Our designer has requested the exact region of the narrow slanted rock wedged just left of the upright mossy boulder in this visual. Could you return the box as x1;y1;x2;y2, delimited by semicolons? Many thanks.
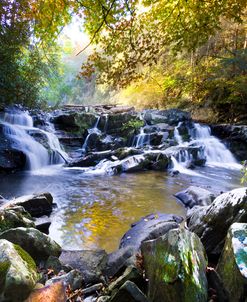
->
108;266;142;292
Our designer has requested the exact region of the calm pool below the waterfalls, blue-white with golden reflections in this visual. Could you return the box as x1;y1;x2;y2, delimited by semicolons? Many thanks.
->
0;165;241;252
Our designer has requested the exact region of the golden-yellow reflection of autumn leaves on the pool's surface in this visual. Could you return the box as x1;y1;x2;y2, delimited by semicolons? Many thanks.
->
58;172;185;252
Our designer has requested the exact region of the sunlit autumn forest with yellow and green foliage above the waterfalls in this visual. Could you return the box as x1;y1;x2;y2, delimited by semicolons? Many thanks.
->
0;0;247;122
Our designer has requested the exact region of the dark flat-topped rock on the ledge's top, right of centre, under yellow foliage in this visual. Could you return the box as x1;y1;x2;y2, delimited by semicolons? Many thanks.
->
144;109;191;125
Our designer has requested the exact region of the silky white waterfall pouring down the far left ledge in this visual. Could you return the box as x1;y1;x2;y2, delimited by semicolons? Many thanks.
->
1;110;67;170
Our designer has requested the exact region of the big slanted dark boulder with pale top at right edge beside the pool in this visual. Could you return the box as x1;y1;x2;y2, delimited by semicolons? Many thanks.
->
187;188;247;256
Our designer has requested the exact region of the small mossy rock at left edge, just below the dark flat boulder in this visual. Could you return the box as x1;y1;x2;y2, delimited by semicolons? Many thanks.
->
0;207;35;233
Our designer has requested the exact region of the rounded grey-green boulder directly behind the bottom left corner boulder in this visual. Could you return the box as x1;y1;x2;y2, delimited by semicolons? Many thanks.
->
0;227;61;263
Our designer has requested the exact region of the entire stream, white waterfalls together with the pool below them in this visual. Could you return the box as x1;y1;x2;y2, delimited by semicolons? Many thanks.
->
0;108;243;251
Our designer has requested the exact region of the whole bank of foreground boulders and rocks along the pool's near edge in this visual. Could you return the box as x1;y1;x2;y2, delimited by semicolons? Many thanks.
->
0;187;247;302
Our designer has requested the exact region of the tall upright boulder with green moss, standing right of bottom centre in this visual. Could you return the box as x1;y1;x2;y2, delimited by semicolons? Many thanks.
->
141;229;208;302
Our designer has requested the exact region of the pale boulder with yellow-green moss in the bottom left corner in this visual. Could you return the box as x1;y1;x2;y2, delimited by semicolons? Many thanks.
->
0;240;38;302
